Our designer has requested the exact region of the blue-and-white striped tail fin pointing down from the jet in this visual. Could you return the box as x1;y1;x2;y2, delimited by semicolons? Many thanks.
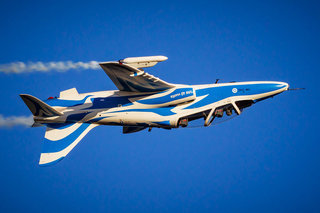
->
39;123;98;166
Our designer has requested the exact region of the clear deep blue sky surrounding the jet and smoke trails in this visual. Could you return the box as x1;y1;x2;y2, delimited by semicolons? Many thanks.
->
0;1;320;212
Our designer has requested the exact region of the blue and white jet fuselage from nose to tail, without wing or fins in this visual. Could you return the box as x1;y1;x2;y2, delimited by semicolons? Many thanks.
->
40;81;288;128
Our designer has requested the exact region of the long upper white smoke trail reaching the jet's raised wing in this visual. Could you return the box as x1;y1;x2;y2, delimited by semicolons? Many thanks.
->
0;61;99;74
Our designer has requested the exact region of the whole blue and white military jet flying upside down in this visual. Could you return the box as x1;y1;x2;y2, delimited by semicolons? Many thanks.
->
20;56;289;165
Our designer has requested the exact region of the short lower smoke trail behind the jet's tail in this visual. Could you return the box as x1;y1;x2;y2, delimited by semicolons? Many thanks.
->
0;114;33;128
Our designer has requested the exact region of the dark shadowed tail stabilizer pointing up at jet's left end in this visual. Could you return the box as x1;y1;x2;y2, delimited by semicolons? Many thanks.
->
20;94;62;117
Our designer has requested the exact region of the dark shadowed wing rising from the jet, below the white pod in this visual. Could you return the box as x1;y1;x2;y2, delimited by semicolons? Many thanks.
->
100;62;174;92
